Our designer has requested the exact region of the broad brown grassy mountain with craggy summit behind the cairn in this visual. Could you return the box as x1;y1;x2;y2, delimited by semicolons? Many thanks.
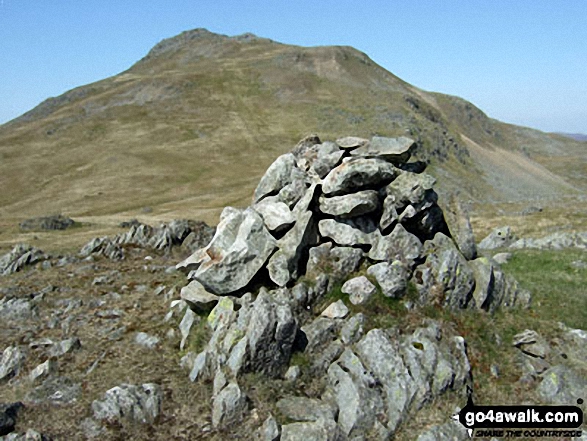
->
0;29;587;227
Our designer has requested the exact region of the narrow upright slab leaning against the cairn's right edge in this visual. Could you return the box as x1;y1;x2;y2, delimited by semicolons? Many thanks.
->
441;194;477;260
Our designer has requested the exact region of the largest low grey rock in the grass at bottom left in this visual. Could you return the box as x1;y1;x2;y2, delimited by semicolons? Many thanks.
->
92;383;163;424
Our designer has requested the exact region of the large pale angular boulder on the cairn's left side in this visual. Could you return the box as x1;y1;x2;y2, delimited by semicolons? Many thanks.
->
194;208;276;295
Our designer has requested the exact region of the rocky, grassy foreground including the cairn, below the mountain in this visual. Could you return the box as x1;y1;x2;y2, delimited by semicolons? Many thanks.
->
0;134;587;441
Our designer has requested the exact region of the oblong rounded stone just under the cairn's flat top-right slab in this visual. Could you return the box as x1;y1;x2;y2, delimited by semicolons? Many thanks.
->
322;158;399;196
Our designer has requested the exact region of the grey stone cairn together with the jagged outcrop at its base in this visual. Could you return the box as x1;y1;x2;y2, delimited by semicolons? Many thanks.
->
177;135;530;439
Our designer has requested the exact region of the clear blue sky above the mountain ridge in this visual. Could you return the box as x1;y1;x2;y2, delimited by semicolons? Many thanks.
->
0;0;587;133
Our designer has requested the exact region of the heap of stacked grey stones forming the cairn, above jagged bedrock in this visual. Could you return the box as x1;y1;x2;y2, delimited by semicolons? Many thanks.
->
177;136;528;311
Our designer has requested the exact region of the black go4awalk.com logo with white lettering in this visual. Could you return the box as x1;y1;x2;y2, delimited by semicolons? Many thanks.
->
453;394;583;439
